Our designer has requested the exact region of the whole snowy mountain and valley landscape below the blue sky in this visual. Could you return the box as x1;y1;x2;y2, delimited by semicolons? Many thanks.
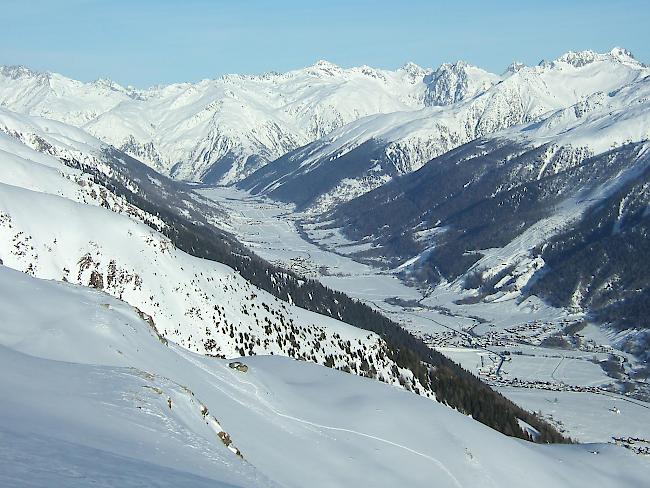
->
0;31;650;488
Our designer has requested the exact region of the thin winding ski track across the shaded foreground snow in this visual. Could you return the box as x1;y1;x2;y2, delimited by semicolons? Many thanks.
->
177;348;462;488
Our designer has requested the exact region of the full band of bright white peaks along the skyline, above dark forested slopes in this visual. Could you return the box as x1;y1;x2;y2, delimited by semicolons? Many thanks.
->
0;48;644;196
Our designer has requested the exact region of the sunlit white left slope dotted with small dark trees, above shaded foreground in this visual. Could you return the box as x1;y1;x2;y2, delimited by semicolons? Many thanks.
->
0;107;422;392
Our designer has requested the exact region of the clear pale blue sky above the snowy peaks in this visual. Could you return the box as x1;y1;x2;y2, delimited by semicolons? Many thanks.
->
0;0;650;87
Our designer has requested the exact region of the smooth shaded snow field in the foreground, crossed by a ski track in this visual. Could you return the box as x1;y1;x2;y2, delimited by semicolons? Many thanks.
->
0;267;650;488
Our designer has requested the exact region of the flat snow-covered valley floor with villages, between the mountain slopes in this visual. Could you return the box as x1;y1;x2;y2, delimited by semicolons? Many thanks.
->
199;187;650;448
